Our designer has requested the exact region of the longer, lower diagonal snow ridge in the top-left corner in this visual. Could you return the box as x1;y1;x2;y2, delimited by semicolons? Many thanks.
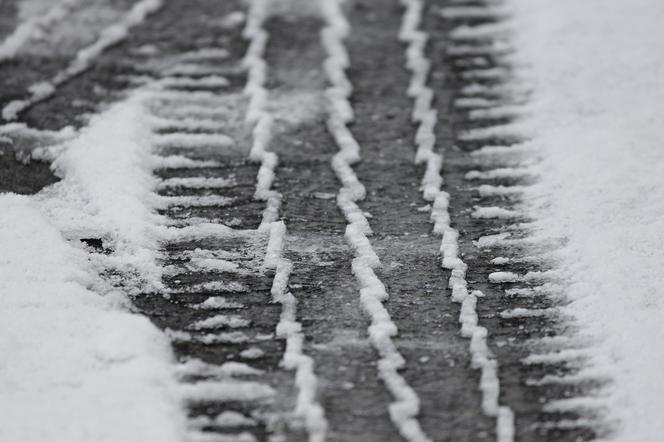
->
2;0;163;120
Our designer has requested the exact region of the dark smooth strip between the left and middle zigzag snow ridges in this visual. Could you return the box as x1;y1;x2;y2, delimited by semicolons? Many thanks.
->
266;9;400;442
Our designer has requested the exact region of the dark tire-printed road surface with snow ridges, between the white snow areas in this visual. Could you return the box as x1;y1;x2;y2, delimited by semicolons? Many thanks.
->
0;0;603;442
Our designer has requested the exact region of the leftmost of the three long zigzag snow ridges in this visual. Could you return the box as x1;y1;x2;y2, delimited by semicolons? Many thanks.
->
243;0;327;442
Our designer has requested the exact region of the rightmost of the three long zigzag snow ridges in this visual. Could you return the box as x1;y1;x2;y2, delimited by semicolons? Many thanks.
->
399;0;514;442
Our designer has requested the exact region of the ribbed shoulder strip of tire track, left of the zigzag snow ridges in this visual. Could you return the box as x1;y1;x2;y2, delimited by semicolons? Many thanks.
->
136;49;293;442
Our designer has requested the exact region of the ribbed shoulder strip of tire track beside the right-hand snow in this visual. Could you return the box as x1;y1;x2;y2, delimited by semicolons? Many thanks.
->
426;1;604;441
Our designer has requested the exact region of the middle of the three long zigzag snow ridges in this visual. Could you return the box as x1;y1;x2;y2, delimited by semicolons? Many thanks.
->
320;0;431;442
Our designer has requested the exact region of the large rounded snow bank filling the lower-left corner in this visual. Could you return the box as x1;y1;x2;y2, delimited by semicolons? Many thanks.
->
0;194;185;442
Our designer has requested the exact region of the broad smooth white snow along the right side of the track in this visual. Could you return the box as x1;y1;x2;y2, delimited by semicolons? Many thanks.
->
510;0;664;442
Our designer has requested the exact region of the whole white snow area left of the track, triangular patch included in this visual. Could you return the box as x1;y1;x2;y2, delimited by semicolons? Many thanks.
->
0;96;185;442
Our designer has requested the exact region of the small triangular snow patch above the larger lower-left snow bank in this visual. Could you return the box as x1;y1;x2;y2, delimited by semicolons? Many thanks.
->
36;94;162;291
